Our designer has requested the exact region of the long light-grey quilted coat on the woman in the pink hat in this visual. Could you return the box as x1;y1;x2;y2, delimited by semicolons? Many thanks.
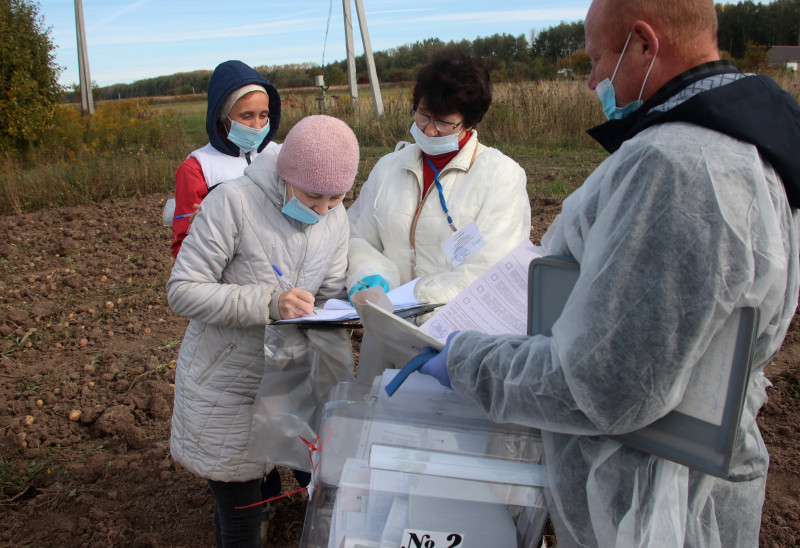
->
167;146;349;482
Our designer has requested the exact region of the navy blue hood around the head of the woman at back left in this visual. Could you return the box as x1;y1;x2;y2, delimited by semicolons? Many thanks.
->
206;61;281;156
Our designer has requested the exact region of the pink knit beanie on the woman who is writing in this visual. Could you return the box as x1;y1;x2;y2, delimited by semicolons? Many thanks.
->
278;114;358;195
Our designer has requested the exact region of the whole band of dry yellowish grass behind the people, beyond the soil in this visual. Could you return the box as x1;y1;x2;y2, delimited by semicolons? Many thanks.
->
0;73;800;214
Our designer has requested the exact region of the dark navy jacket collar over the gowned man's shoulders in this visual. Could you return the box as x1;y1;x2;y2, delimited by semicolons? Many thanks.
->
587;61;800;209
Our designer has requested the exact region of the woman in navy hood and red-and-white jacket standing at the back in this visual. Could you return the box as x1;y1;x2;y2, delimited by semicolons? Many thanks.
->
172;61;281;257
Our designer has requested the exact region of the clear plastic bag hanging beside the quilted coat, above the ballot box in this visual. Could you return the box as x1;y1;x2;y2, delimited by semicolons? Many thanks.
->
249;325;355;472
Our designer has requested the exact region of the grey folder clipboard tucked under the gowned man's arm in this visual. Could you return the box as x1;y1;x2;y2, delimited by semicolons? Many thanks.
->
528;256;758;479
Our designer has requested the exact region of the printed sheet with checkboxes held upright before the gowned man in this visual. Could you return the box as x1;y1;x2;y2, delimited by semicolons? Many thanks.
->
420;240;542;341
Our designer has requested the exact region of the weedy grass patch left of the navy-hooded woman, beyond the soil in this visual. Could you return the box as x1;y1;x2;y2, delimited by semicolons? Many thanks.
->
0;101;186;214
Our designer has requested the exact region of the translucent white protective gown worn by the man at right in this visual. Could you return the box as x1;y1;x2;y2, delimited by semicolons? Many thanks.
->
447;70;800;548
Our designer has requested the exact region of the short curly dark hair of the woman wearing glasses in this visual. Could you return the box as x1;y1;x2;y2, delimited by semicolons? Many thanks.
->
413;48;492;127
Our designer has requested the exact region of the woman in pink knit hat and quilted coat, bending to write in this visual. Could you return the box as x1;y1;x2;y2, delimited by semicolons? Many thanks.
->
167;115;359;547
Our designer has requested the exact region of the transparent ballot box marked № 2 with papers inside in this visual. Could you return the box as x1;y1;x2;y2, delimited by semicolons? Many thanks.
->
300;370;547;548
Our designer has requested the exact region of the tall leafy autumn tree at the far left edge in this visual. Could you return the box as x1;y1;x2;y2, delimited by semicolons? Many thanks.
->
0;0;61;152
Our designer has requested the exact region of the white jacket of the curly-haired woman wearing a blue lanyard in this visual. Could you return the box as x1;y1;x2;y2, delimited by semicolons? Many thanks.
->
347;130;531;303
